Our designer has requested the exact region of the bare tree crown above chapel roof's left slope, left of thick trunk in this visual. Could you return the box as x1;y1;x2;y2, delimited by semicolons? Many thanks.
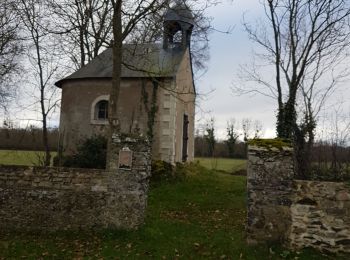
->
48;0;113;68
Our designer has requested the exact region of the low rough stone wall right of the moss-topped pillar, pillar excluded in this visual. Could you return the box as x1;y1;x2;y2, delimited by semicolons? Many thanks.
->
288;180;350;253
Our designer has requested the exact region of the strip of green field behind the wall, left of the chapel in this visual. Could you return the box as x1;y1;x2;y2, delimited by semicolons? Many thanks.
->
0;150;56;166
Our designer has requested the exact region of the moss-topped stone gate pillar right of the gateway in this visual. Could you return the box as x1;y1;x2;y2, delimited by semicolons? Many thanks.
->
247;140;294;244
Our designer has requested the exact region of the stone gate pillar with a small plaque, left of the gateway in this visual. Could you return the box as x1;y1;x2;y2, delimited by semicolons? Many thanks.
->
106;134;151;228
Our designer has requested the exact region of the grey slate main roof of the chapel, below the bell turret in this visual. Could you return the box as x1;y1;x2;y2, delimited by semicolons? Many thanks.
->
55;43;185;87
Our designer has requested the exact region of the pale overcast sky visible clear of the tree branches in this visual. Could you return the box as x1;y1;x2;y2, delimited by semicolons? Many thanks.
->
2;0;350;139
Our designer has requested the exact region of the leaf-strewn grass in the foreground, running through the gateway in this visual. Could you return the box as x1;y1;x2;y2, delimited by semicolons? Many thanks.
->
0;166;338;260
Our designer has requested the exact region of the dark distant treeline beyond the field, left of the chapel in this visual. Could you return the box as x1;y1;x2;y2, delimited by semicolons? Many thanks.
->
0;127;58;151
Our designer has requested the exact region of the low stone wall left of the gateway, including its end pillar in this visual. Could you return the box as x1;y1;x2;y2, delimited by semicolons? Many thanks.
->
0;135;151;232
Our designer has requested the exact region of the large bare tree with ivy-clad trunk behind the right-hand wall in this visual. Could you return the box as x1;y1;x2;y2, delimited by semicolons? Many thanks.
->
239;0;350;176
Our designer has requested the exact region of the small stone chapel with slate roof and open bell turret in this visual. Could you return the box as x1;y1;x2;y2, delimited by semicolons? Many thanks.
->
56;3;196;163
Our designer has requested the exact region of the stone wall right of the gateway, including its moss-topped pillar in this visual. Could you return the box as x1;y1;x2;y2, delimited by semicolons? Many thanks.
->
247;143;350;253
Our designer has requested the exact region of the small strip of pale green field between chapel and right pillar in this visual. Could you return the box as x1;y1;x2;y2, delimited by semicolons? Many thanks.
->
195;158;247;173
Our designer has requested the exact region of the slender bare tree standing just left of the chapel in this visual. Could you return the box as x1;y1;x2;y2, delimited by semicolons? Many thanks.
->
16;0;59;166
